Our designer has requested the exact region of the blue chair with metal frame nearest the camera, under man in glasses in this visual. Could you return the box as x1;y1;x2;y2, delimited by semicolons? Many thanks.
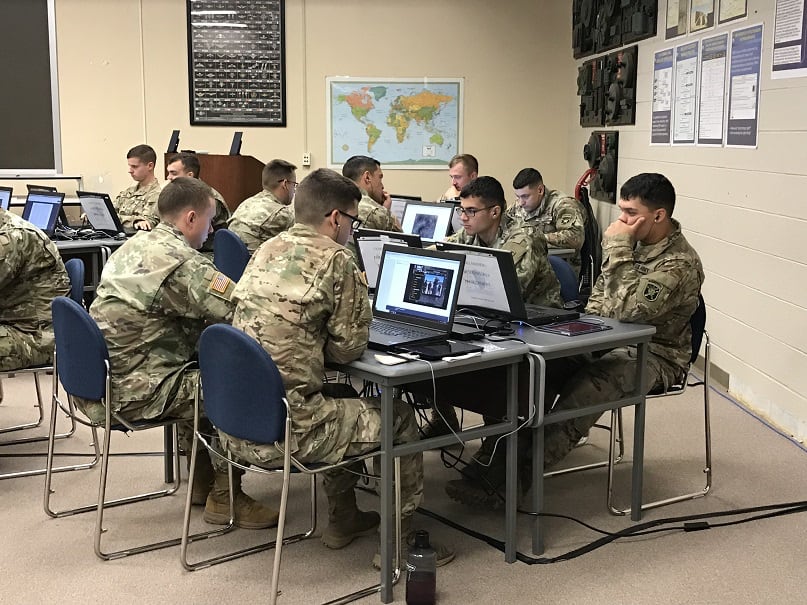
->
180;324;401;604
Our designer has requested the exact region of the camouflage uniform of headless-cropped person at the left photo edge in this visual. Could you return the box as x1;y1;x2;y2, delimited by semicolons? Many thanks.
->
0;208;70;370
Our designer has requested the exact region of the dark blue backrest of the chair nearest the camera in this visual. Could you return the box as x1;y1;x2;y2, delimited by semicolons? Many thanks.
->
199;324;286;443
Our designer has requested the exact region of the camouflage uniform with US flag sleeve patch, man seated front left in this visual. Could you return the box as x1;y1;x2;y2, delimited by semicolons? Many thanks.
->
77;223;235;448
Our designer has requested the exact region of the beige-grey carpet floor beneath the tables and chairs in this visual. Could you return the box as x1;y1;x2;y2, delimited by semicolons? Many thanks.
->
0;368;807;605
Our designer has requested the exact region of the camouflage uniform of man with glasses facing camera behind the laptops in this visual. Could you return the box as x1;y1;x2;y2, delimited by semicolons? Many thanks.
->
446;214;563;308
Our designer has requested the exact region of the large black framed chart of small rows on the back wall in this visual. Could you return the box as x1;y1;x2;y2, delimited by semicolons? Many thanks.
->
186;0;286;126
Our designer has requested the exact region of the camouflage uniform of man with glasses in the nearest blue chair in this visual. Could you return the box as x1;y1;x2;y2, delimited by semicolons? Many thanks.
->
220;223;423;515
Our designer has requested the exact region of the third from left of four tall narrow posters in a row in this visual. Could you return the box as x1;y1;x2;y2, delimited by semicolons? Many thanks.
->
698;34;729;145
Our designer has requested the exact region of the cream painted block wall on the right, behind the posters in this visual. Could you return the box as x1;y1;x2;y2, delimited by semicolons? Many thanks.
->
567;0;807;441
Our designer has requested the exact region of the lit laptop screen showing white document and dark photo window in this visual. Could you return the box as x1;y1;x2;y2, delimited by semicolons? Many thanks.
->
373;246;464;326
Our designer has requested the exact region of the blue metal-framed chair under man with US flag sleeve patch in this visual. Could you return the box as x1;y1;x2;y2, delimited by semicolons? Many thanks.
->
44;297;180;560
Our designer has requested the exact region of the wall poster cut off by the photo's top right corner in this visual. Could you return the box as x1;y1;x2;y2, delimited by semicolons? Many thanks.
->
771;0;807;80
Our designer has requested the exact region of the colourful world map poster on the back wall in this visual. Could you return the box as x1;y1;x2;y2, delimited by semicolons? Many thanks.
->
327;77;463;170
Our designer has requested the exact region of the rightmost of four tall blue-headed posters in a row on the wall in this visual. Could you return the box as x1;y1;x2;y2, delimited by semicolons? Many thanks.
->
726;23;762;147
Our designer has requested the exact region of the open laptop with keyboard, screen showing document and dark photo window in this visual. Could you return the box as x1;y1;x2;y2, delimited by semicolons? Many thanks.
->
368;244;465;351
